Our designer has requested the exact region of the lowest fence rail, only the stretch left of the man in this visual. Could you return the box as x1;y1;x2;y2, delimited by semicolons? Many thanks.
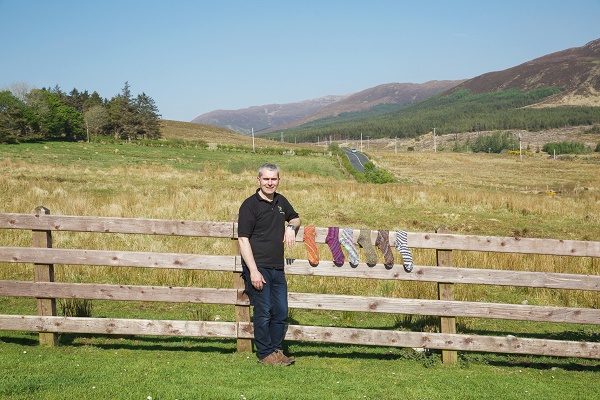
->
0;315;237;338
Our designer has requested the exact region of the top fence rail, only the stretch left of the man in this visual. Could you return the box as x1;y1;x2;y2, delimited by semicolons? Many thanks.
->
0;213;234;238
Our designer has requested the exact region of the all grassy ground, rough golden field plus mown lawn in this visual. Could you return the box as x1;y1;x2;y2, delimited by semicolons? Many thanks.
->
0;130;600;400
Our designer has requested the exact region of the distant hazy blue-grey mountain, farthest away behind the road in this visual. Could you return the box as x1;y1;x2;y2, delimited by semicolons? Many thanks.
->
192;96;348;135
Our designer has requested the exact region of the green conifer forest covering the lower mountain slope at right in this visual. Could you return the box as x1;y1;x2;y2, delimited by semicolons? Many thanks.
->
264;87;600;142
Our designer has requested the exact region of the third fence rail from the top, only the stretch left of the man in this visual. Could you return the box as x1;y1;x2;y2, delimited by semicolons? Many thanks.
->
0;280;239;305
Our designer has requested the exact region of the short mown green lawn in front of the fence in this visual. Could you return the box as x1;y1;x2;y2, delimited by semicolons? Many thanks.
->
0;332;600;400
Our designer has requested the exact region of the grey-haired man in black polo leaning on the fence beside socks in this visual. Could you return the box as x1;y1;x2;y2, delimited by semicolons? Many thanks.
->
238;164;300;366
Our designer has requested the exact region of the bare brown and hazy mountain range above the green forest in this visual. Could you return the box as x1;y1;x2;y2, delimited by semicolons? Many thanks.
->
192;39;600;134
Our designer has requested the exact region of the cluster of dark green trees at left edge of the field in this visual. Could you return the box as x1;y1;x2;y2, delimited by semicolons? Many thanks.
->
0;82;161;143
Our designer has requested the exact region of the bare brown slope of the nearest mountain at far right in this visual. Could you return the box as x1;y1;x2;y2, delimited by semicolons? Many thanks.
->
451;39;600;107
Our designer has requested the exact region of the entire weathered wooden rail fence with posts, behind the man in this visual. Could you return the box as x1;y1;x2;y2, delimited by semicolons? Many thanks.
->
0;207;600;363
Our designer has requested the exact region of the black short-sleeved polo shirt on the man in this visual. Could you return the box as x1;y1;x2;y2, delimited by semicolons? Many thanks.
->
238;189;298;269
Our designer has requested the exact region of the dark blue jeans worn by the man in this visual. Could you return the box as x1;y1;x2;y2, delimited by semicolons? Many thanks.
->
244;267;288;359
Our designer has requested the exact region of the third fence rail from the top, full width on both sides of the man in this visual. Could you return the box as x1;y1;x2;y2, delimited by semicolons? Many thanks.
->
0;281;600;325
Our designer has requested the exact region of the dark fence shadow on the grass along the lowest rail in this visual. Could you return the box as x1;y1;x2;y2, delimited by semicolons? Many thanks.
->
0;330;600;372
